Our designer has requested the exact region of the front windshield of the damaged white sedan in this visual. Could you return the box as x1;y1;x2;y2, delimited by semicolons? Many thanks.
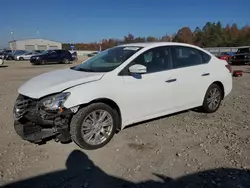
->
71;46;142;72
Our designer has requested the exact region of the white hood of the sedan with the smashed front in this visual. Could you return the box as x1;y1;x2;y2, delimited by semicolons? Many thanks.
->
18;68;105;99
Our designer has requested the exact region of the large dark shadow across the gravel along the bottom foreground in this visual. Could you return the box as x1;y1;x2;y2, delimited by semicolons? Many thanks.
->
3;150;250;188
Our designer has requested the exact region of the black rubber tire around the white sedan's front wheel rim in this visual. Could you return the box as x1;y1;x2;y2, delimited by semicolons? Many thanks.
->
70;103;120;150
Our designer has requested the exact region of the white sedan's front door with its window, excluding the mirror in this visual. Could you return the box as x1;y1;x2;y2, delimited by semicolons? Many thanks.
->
122;47;176;124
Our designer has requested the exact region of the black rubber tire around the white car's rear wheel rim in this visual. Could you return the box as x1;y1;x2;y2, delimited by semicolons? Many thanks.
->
201;84;223;113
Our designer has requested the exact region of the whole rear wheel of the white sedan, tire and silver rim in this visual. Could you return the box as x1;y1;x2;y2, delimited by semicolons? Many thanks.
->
202;84;223;113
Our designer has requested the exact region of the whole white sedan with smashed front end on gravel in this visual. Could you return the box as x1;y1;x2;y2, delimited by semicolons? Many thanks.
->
13;42;232;149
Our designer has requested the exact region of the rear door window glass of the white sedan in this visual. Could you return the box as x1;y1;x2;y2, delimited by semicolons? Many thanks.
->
172;46;211;68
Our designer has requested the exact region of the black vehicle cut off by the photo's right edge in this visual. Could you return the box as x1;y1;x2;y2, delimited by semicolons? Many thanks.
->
231;46;250;65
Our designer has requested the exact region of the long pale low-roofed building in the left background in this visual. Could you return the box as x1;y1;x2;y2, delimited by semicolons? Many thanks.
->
9;38;62;51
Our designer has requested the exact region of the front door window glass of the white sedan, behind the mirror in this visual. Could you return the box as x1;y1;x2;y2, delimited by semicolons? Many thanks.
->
133;47;171;73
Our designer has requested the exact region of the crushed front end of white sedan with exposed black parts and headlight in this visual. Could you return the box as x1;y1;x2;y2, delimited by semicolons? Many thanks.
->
13;93;73;144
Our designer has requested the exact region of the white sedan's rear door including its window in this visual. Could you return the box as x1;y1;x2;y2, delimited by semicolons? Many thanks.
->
171;46;212;110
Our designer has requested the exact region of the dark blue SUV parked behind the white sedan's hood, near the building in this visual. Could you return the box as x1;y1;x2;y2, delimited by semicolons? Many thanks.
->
30;50;74;65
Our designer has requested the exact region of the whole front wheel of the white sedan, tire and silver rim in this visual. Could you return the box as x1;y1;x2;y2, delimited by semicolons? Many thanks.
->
70;103;119;150
